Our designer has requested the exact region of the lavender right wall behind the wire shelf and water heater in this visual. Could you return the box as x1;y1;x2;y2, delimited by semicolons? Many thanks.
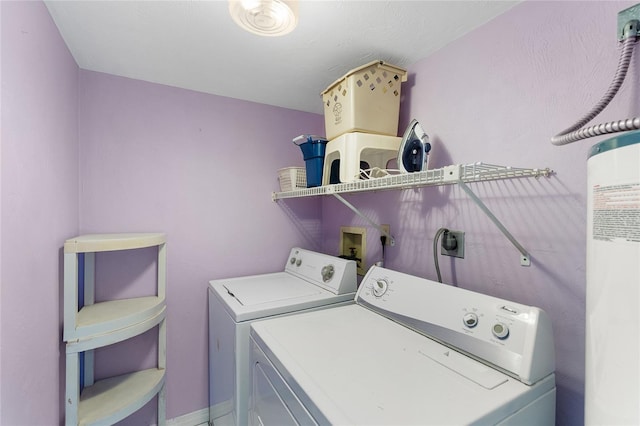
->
323;1;640;425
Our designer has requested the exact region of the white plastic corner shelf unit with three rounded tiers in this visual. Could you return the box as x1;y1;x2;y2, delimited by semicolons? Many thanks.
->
63;233;167;425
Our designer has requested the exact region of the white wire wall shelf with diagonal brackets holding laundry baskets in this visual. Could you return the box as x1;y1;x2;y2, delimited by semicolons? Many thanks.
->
271;162;553;266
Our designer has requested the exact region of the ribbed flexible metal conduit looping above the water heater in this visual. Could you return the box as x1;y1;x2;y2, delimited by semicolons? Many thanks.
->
551;37;640;146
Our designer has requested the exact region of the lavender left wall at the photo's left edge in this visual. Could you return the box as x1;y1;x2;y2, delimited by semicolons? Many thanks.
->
0;1;78;425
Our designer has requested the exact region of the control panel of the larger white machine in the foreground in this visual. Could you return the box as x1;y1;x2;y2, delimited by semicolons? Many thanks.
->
356;266;555;384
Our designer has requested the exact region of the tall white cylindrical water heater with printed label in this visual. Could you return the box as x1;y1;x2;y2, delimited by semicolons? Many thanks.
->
585;131;640;425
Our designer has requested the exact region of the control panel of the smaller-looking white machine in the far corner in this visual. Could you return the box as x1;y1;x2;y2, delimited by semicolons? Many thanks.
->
284;247;358;294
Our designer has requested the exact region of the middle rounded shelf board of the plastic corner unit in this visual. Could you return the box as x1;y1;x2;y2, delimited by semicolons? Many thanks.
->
65;296;165;341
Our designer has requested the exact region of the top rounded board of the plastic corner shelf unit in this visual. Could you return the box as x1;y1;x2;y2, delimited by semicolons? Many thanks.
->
64;233;166;253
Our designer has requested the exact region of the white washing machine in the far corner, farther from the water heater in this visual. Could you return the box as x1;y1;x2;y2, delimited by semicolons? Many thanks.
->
208;248;357;426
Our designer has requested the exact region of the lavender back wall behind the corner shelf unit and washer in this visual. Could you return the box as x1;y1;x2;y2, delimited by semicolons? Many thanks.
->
79;71;323;424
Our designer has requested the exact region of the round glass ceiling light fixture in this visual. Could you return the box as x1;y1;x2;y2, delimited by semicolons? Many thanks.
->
229;0;298;36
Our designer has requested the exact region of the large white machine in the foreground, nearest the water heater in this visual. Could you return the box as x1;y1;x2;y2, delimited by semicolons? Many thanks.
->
249;266;556;426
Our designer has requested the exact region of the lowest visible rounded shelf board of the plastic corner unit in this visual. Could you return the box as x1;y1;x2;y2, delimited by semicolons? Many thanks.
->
78;368;165;425
